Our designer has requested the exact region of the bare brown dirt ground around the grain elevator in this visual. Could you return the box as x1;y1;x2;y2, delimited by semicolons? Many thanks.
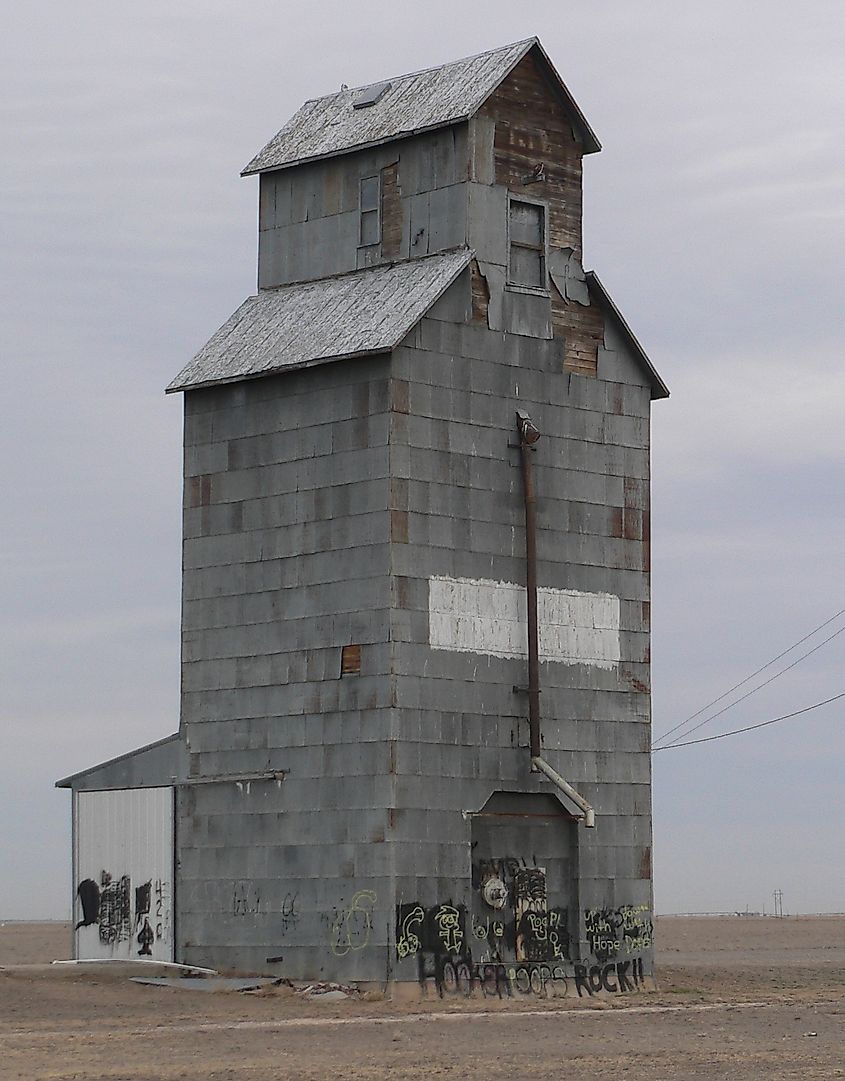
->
0;916;845;1081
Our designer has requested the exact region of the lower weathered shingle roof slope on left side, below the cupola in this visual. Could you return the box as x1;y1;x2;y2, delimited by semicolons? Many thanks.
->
167;248;472;393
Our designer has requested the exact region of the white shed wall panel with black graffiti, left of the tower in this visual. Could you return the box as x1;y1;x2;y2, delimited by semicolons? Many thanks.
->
73;788;173;961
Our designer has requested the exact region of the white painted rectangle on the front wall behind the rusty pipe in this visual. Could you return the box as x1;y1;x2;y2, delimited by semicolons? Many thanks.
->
428;577;620;668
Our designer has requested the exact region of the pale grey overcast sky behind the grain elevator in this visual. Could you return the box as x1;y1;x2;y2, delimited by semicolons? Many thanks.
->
0;0;845;919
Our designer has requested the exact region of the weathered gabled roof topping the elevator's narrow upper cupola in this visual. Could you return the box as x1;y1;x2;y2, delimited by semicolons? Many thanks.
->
241;38;601;176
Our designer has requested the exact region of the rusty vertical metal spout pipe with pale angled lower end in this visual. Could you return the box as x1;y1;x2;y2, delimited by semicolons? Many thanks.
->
517;410;595;829
